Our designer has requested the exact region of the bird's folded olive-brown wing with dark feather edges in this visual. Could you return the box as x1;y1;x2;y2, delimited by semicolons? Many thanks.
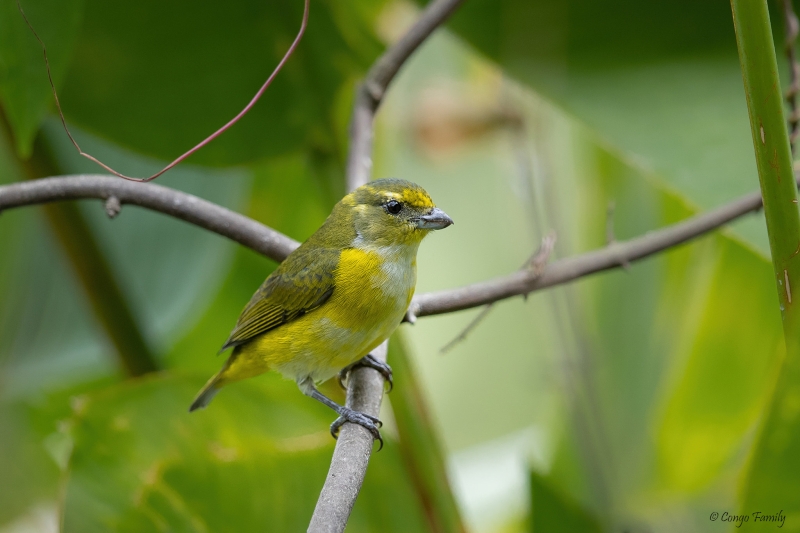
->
220;248;341;351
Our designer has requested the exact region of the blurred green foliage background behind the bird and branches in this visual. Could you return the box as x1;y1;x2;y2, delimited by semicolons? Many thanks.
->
0;0;800;533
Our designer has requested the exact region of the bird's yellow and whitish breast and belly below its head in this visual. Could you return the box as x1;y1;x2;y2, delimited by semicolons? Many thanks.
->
230;243;416;381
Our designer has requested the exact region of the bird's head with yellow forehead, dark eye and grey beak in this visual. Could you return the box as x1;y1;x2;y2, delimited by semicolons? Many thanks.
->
334;179;453;246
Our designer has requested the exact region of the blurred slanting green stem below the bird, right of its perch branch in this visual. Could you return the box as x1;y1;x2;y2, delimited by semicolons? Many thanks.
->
388;333;466;533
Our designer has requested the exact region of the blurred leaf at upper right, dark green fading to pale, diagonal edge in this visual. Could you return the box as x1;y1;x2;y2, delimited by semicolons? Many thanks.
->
438;0;767;251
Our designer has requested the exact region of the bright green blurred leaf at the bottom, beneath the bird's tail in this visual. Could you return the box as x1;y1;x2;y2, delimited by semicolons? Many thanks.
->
64;375;432;533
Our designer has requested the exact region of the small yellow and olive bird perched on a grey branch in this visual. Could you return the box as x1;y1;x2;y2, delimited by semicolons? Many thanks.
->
189;179;453;440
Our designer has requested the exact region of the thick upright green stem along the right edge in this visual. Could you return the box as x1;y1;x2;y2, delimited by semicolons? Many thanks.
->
731;0;800;516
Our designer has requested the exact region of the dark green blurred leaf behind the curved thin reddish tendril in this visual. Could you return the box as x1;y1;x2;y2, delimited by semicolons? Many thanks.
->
55;0;382;165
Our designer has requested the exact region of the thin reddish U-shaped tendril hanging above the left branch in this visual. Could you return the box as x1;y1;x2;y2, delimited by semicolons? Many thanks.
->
17;0;309;182
